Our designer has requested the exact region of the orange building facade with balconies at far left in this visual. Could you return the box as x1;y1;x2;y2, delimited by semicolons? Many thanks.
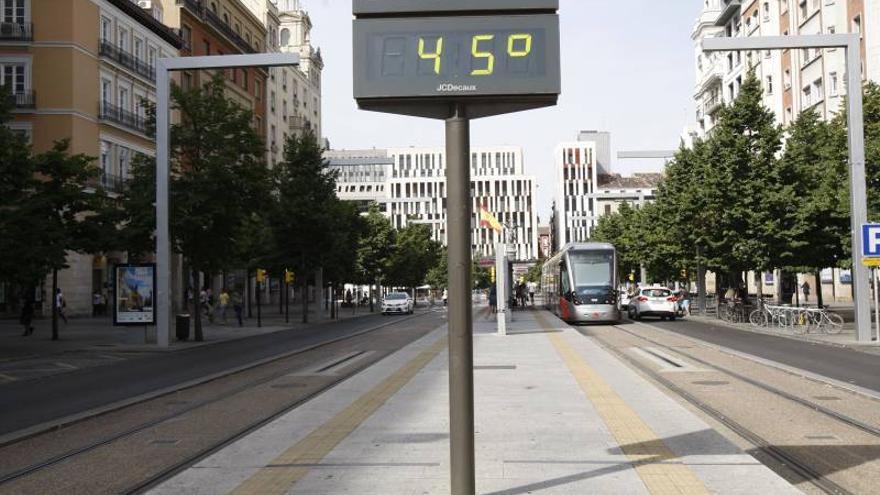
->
0;0;182;314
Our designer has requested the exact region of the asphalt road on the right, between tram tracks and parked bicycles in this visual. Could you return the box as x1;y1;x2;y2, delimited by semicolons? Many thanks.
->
644;319;880;392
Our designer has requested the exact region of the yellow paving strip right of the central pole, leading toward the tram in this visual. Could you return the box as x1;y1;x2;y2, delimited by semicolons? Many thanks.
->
537;313;709;495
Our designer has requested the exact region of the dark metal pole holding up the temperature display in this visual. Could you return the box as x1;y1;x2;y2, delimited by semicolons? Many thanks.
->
446;105;476;495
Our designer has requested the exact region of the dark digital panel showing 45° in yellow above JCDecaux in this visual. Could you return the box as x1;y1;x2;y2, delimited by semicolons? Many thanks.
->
354;14;560;98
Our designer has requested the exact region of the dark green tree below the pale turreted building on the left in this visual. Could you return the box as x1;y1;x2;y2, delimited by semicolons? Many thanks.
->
269;133;339;323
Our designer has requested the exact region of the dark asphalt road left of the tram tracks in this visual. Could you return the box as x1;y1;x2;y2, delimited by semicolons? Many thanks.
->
0;315;438;435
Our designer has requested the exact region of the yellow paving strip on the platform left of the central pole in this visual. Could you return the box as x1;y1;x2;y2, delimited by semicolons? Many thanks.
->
231;337;447;495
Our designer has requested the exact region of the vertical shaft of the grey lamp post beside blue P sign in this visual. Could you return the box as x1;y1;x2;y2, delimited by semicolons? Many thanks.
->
846;36;871;342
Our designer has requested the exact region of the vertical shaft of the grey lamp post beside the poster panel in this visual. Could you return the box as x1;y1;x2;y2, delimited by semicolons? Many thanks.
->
156;59;171;347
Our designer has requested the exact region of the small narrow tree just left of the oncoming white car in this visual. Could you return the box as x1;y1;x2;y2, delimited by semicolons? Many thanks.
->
357;204;396;312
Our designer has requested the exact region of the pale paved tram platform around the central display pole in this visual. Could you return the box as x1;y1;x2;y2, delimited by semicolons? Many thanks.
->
151;308;800;495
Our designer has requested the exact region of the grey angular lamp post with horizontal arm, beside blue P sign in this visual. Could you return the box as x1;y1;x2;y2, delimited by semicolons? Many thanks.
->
702;33;871;342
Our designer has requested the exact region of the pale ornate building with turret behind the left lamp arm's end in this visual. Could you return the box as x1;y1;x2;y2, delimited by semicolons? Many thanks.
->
241;0;324;167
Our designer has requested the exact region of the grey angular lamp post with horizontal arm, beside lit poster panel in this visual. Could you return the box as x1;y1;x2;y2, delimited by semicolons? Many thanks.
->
155;53;299;347
